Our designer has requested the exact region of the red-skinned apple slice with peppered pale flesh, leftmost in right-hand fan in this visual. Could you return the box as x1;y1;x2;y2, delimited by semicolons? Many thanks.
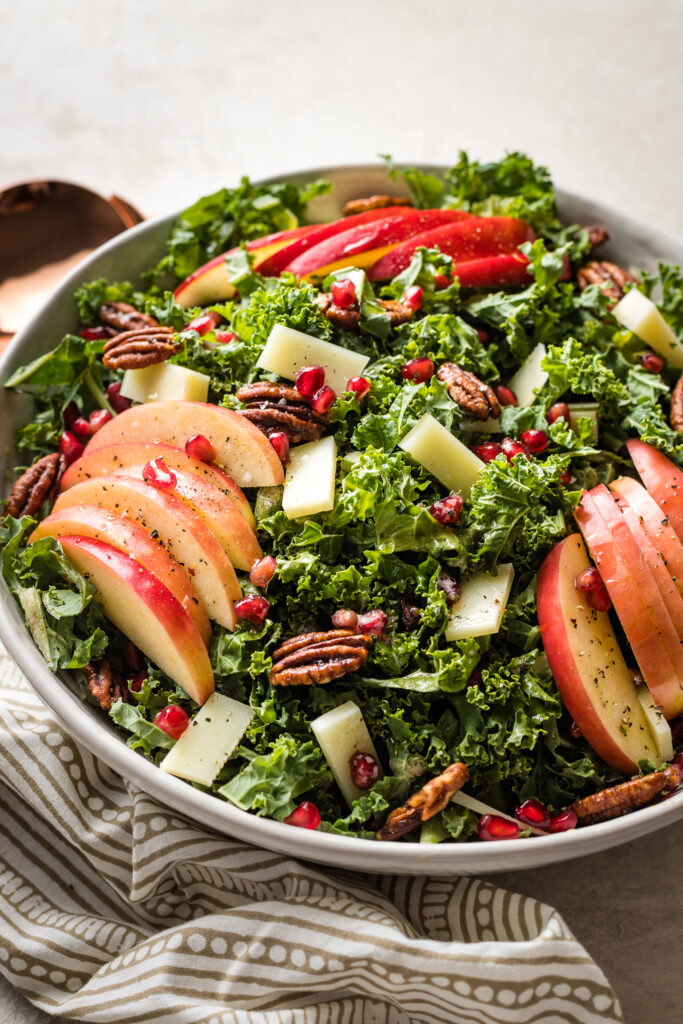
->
537;534;657;775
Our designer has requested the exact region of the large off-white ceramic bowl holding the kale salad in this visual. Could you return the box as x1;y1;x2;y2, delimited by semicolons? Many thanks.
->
0;165;683;876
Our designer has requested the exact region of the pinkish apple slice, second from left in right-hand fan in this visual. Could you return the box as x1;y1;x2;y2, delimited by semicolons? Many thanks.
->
574;484;683;720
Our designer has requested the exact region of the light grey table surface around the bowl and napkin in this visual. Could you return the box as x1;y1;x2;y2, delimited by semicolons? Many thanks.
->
0;0;683;1024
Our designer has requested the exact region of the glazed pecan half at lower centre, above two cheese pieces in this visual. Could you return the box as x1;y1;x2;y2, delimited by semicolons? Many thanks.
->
268;630;373;686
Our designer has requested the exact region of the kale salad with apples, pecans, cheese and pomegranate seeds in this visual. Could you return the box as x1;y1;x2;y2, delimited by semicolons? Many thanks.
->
0;153;683;843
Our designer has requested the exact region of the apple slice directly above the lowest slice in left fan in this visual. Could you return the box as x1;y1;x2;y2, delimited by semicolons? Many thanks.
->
29;505;211;645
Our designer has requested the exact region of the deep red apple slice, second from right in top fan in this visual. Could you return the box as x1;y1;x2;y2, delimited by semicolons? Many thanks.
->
368;217;536;281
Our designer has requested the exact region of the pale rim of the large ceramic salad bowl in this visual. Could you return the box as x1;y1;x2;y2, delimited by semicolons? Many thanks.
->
0;163;683;874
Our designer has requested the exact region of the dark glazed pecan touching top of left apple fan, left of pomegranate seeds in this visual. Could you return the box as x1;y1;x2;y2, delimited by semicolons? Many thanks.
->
238;381;330;444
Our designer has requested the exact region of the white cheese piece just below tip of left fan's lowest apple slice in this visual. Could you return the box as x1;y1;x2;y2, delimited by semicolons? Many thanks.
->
160;693;254;785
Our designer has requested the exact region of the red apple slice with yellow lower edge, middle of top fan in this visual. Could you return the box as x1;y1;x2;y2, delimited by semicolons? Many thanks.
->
285;209;470;280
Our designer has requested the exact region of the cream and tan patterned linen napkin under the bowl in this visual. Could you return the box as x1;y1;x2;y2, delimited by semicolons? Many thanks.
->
0;648;623;1024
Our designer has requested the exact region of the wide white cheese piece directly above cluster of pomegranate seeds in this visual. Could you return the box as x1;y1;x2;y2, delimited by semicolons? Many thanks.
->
256;324;370;393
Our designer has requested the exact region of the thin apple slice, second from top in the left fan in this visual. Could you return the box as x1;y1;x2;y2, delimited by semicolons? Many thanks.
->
59;441;256;529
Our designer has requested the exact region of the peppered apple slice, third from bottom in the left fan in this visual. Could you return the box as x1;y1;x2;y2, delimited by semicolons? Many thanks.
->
53;476;237;630
